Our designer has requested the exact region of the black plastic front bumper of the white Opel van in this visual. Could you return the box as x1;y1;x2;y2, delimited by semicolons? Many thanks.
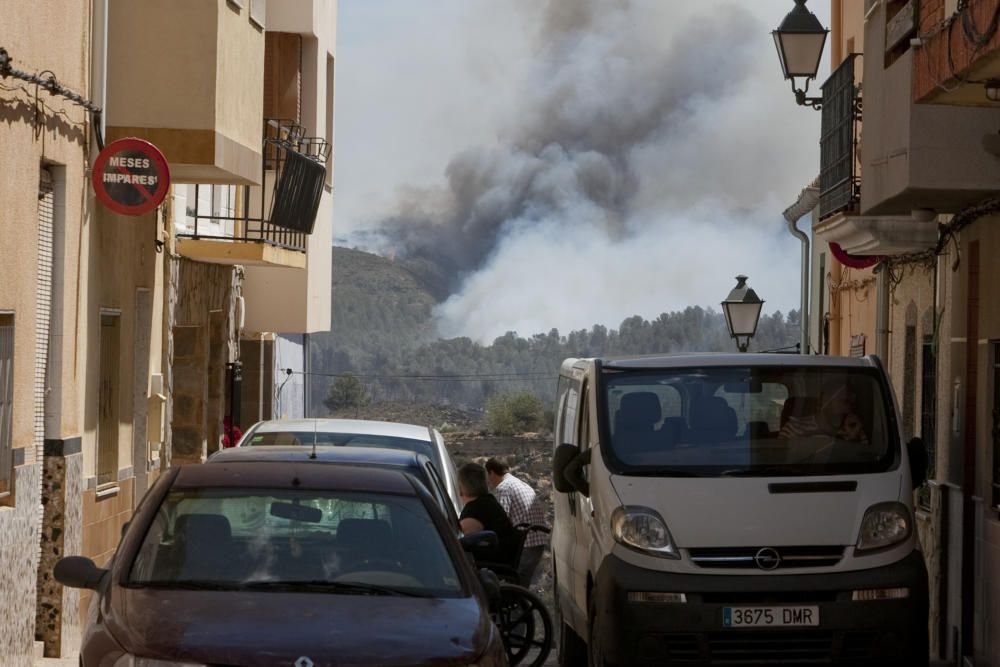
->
593;551;928;667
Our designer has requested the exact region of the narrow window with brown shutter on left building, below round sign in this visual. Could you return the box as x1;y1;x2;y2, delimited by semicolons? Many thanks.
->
97;312;121;488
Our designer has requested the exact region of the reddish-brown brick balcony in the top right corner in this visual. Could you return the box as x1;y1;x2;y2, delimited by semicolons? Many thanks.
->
913;0;1000;108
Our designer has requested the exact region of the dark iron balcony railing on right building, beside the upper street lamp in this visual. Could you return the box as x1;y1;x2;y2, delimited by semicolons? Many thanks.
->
819;54;861;220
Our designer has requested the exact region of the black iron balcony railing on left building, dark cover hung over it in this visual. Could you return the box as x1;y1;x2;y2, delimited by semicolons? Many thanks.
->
177;119;330;252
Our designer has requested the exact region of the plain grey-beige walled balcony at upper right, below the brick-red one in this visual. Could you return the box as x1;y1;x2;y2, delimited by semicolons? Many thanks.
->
860;2;1000;218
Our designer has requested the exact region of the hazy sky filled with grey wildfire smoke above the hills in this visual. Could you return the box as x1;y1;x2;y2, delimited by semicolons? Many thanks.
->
334;0;830;342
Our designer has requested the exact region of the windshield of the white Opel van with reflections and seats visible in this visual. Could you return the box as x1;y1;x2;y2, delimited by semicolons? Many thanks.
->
602;366;898;477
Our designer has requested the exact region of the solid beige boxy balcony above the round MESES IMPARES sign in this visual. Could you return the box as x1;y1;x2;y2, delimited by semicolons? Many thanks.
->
107;0;264;185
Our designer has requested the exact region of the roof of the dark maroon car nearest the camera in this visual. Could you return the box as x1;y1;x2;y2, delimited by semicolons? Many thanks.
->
173;461;416;496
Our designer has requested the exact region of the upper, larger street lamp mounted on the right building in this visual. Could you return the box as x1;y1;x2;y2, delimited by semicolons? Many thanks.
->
771;0;830;109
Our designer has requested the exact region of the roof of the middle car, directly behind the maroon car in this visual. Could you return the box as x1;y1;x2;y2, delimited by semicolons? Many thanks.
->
206;445;427;467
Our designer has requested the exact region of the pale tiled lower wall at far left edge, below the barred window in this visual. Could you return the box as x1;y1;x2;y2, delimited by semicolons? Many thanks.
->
0;464;41;667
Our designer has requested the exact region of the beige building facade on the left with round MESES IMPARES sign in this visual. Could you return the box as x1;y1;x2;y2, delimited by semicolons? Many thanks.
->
0;0;336;667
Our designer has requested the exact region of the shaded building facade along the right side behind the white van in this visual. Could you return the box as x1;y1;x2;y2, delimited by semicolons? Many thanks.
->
796;0;1000;665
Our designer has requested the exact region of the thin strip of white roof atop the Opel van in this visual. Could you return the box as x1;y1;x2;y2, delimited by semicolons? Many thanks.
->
563;352;876;371
